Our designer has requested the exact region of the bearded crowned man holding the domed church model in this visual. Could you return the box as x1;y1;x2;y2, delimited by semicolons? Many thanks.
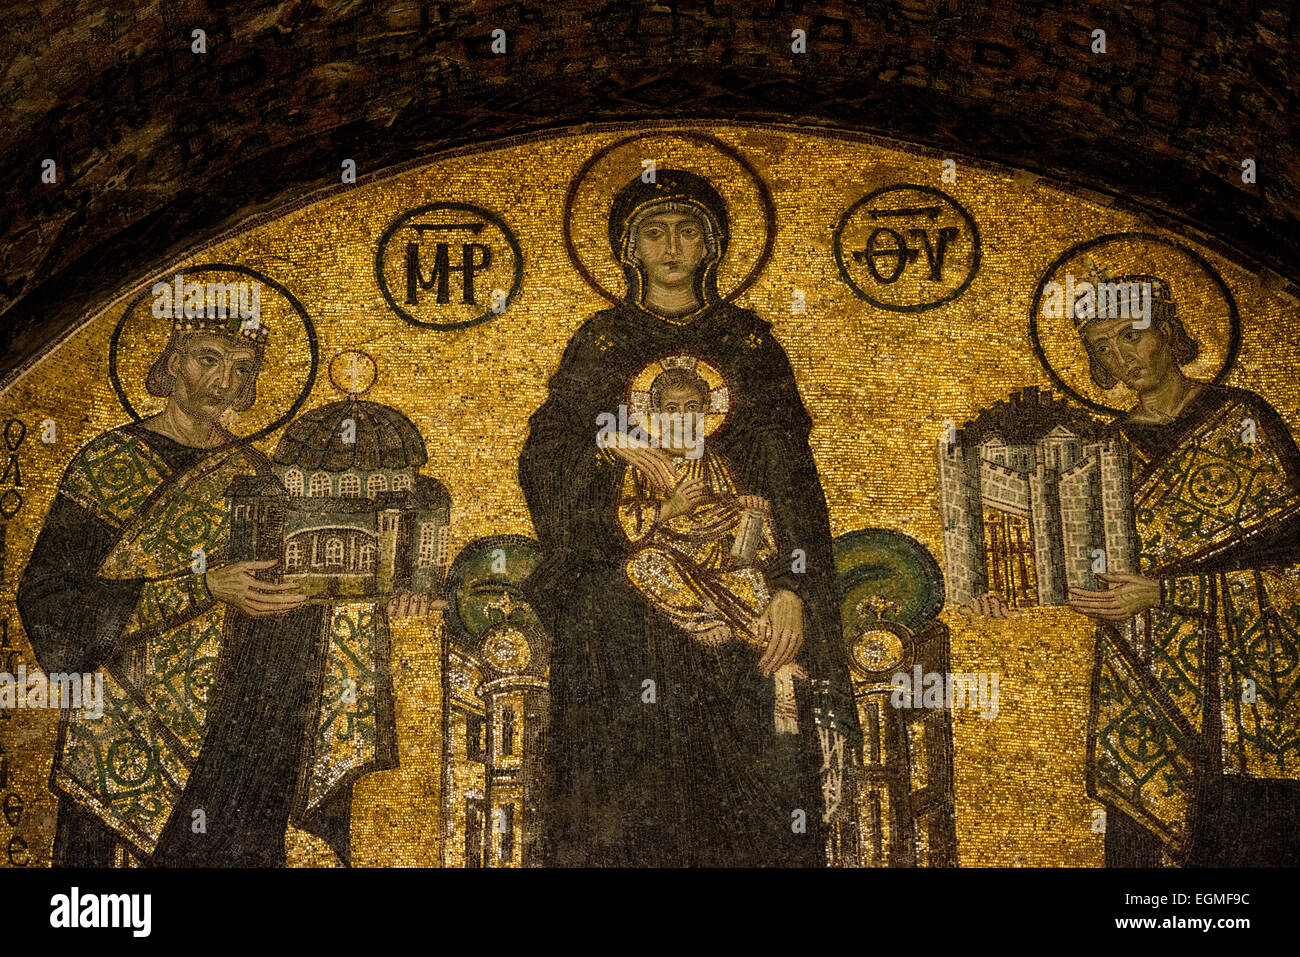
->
17;309;390;867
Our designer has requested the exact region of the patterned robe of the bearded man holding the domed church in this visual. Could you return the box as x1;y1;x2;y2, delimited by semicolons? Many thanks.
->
18;424;395;866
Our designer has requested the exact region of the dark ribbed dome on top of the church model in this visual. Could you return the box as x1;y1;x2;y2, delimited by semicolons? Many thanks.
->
272;398;429;472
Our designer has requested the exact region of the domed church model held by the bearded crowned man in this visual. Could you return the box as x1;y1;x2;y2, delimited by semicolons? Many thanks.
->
226;395;451;599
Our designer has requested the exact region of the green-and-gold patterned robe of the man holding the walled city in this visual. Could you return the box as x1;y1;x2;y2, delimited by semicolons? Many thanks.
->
1088;386;1300;863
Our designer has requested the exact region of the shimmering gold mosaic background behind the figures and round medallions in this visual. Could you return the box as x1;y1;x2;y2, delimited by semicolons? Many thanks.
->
0;125;1300;866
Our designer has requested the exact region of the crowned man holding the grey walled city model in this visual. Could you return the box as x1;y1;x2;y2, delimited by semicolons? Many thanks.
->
975;273;1300;867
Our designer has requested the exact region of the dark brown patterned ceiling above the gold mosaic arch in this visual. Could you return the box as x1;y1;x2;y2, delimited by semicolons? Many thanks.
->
0;0;1300;374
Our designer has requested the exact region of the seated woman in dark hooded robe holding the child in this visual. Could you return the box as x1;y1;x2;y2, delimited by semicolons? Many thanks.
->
519;169;857;866
